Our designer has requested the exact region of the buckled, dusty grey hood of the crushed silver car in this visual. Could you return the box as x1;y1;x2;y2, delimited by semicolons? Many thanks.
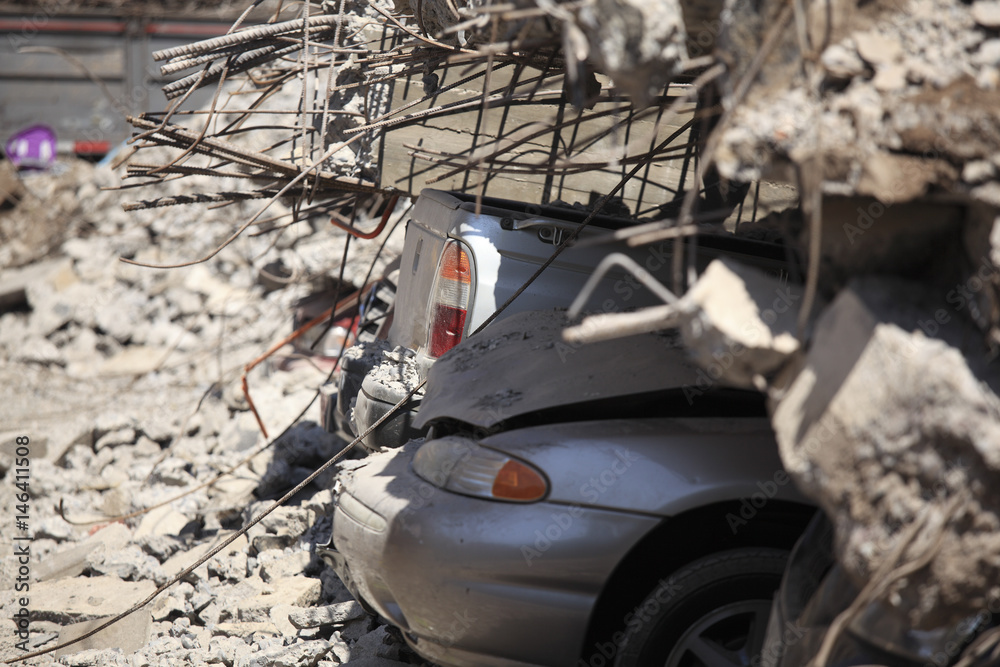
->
414;310;711;428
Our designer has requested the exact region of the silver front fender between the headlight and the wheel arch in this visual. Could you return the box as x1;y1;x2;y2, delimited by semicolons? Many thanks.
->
481;418;809;517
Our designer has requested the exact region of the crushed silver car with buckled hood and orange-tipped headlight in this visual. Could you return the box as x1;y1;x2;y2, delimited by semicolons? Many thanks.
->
324;311;812;667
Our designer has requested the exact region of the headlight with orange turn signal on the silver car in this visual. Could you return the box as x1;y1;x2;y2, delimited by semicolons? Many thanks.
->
413;437;549;503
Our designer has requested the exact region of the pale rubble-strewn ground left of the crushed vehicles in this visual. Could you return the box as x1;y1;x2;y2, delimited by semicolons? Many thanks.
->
0;154;415;667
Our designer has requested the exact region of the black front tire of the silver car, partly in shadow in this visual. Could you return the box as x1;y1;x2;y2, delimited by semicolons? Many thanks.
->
615;548;788;667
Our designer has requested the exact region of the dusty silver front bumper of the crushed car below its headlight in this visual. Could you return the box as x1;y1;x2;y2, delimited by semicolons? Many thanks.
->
334;445;659;667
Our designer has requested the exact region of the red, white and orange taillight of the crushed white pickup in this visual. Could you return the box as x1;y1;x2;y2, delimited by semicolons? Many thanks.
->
429;241;472;358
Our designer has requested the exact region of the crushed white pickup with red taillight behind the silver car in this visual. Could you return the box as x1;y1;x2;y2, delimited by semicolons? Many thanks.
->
323;190;788;451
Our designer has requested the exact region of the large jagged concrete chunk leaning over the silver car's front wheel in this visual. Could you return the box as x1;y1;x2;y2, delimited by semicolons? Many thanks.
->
772;278;1000;628
